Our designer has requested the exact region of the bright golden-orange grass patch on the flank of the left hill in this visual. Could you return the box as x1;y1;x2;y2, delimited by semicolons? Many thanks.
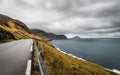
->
0;20;40;39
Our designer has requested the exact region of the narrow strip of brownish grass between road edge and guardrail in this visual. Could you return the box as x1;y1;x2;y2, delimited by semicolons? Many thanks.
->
31;41;40;75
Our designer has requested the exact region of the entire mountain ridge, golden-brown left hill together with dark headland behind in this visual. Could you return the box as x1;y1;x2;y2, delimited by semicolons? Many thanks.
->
0;14;67;41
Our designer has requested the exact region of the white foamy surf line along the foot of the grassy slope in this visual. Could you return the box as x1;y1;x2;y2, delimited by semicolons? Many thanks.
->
49;43;120;74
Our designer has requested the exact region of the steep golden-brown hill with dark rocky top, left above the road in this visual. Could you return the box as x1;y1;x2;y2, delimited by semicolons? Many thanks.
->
0;14;41;41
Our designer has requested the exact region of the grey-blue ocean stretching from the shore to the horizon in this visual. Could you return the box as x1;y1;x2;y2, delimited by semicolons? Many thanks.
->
50;39;120;70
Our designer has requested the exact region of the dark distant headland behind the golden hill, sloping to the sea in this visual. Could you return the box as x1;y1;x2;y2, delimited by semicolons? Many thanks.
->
31;29;67;39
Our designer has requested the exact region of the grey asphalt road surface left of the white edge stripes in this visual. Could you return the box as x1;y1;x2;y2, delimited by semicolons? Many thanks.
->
0;39;33;75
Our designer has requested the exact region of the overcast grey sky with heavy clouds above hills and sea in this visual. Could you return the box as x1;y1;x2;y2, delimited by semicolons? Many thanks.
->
0;0;120;38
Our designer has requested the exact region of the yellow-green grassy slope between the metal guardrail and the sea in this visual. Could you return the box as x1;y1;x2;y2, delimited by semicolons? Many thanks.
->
39;41;118;75
